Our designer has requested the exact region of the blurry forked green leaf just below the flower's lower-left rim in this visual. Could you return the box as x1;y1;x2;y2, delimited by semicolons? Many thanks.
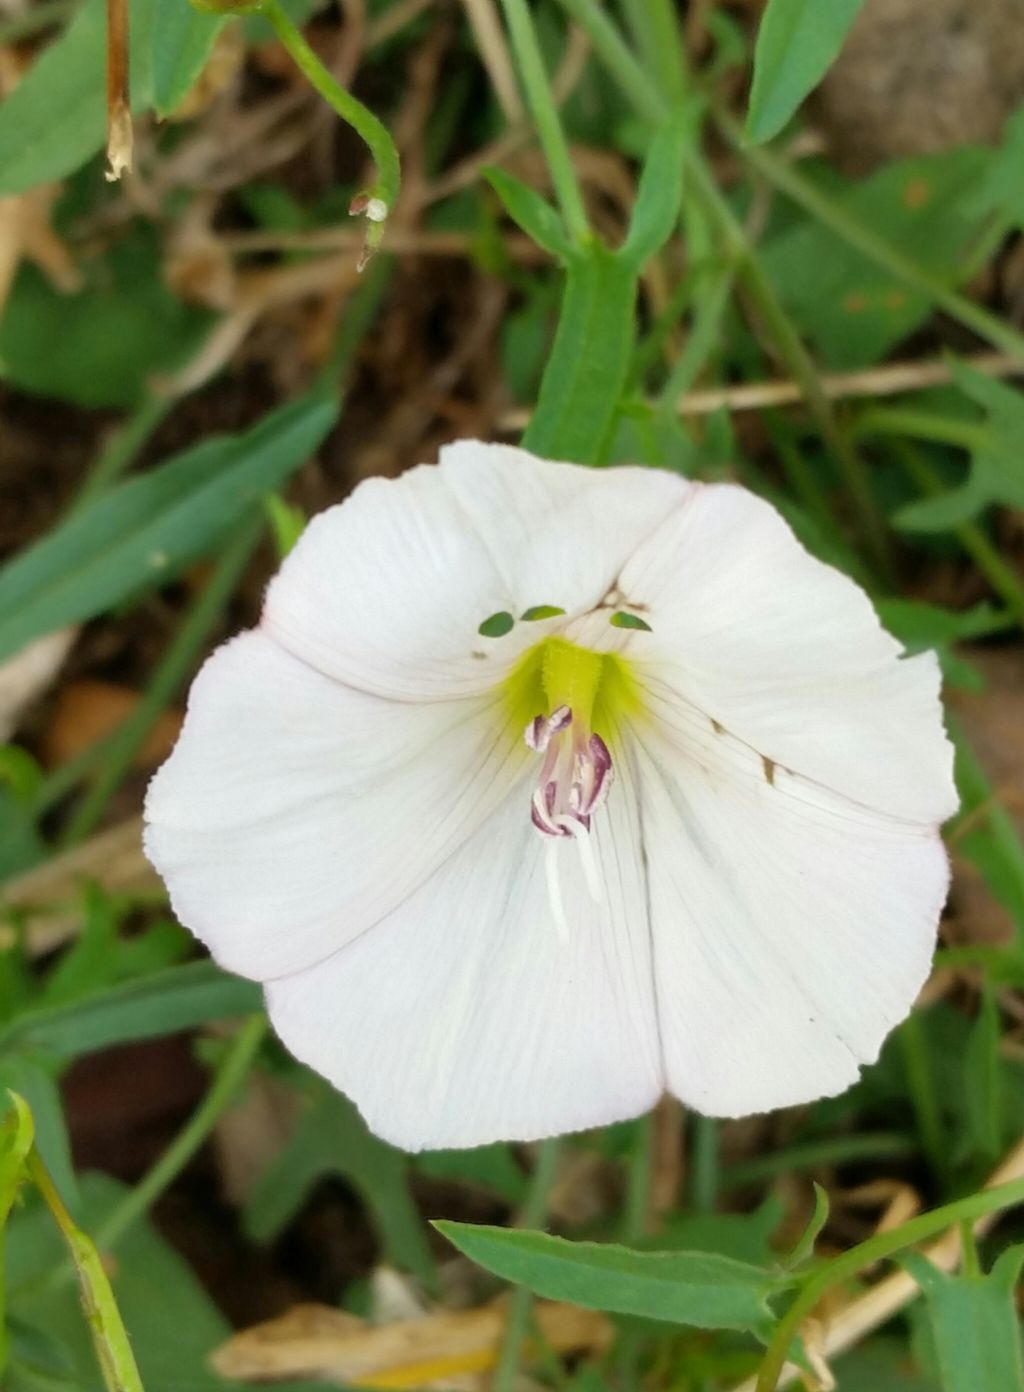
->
243;1075;435;1289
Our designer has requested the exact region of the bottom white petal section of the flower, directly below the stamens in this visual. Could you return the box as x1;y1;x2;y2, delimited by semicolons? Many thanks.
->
267;757;662;1150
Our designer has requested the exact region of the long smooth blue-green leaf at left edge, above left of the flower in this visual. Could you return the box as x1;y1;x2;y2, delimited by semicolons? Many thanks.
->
0;394;337;658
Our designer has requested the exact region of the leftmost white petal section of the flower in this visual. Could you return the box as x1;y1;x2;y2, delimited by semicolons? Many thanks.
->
146;631;530;980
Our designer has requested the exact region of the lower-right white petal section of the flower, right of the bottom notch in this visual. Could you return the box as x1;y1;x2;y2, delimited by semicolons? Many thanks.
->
637;707;949;1116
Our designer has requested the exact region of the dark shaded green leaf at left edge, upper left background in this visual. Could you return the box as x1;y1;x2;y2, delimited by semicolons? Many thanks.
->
0;226;211;408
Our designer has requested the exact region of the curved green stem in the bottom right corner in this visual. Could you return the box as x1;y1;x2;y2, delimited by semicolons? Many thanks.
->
757;1179;1024;1392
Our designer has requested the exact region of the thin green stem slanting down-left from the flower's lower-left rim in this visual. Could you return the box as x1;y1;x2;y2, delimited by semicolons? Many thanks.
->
96;1015;267;1251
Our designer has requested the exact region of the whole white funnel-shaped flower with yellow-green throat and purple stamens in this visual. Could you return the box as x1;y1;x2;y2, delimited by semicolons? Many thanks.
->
146;441;956;1150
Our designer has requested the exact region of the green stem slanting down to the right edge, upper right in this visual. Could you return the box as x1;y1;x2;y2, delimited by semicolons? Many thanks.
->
717;111;1024;358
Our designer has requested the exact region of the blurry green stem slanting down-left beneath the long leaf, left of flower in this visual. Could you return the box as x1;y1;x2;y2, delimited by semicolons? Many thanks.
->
60;516;263;849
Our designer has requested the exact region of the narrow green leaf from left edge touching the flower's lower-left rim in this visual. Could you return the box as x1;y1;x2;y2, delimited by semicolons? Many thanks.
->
0;962;262;1058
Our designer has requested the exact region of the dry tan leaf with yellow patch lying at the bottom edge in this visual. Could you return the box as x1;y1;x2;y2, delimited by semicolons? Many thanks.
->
211;1299;612;1389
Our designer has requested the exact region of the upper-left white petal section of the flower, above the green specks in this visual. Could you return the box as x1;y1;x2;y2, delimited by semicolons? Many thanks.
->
263;441;690;702
